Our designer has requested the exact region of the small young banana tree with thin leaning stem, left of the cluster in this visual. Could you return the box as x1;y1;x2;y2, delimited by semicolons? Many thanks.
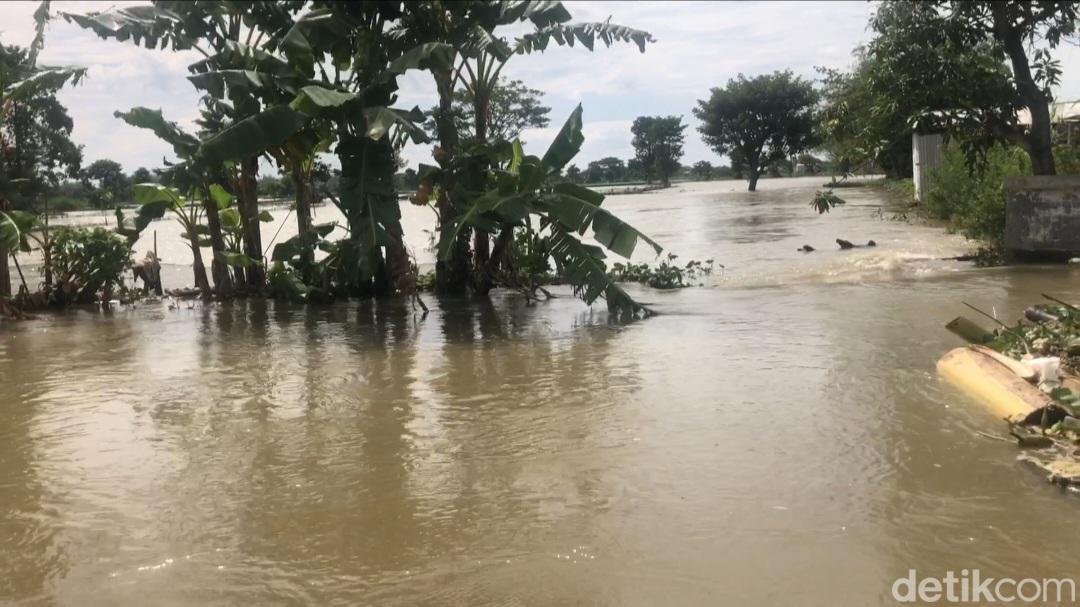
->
132;184;211;297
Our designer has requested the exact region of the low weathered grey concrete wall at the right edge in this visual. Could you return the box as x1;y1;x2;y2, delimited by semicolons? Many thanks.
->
1005;176;1080;255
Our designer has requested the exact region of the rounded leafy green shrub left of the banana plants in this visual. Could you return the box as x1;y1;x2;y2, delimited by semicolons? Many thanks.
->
52;228;132;304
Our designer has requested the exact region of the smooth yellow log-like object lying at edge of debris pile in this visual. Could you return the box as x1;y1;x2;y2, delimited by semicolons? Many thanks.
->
937;347;1050;419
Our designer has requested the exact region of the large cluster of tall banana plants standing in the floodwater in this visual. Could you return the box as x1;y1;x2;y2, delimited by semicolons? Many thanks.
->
56;0;660;314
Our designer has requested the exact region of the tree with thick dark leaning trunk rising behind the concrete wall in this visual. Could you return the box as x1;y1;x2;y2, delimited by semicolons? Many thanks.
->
869;0;1080;175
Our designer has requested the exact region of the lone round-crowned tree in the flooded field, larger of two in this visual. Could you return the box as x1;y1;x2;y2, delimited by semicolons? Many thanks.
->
693;71;818;192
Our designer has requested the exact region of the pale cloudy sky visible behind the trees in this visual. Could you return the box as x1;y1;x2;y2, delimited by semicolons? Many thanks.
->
0;1;1080;172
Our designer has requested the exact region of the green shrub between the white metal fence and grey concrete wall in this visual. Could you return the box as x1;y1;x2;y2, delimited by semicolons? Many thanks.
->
924;143;1031;246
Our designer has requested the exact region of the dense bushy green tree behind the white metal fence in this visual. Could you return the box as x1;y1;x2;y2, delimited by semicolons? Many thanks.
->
842;1;1023;176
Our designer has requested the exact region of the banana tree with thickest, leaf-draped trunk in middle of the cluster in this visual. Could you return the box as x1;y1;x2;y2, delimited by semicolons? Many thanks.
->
192;12;449;295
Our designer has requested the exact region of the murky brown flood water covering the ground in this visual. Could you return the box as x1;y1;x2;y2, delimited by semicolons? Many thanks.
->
0;173;1080;606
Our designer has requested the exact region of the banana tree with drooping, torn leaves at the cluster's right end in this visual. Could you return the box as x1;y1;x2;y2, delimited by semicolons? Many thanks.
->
438;105;663;318
